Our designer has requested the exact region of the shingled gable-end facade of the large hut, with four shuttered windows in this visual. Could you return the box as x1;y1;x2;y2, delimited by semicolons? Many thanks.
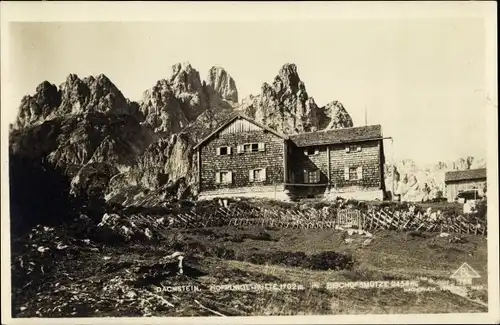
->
196;118;286;193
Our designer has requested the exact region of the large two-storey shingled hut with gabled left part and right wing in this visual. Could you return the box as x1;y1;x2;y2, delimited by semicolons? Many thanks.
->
194;113;385;200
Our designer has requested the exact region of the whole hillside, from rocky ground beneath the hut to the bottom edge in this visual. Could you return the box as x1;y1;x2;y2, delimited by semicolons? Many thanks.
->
12;200;488;317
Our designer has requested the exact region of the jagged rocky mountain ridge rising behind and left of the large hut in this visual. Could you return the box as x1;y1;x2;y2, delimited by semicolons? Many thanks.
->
9;62;482;220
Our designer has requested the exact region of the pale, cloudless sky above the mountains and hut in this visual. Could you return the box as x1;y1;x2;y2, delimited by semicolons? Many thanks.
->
7;18;489;163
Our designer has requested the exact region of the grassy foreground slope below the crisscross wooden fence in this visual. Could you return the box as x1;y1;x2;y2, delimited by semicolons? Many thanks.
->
12;221;487;317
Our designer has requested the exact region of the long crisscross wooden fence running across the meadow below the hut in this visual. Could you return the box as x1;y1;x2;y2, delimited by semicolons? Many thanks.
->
126;206;487;235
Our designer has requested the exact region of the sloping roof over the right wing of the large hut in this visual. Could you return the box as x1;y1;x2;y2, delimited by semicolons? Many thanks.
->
290;125;382;147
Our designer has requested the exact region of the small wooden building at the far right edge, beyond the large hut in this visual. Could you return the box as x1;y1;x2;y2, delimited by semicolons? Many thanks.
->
444;168;486;202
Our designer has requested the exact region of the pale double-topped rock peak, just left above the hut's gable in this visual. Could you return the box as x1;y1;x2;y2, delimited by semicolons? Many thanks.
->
140;62;238;136
